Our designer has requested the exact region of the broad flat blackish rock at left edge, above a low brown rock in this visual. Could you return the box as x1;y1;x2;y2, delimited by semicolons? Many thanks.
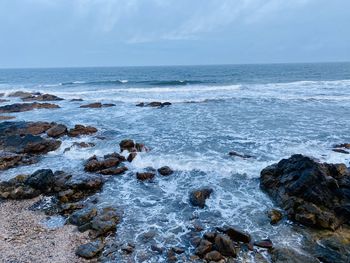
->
0;134;61;154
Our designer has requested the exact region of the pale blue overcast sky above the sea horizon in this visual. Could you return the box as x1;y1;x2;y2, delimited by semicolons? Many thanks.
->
0;0;350;68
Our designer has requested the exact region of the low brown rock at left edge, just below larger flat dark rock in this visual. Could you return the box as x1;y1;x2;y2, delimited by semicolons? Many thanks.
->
0;152;39;170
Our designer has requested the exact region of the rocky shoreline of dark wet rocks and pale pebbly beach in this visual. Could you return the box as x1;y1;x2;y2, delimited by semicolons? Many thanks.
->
0;92;350;262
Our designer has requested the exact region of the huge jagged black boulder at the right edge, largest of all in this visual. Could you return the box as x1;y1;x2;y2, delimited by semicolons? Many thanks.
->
260;155;350;230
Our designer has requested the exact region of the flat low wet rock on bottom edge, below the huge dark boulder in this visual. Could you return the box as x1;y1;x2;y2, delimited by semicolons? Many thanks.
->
270;248;319;263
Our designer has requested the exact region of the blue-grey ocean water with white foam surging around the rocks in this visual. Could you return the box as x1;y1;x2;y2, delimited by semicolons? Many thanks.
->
0;63;350;262
